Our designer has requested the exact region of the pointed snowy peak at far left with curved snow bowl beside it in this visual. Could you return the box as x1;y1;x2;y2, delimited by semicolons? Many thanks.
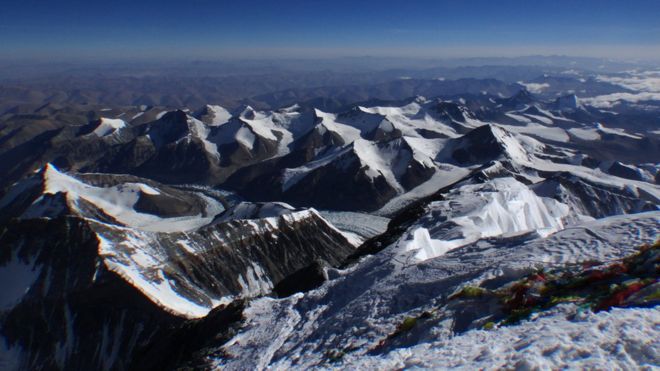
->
0;164;223;231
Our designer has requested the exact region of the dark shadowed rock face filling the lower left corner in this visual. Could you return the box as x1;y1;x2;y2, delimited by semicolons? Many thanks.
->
0;217;183;369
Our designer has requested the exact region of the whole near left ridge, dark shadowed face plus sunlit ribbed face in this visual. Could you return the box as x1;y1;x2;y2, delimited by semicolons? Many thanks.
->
0;213;353;369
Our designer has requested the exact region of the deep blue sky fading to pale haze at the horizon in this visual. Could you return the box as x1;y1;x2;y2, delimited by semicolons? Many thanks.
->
0;0;660;60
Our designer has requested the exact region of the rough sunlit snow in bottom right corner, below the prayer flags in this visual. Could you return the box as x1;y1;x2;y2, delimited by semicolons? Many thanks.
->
352;305;660;370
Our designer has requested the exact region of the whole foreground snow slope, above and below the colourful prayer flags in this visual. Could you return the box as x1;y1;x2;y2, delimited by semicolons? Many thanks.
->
214;212;660;370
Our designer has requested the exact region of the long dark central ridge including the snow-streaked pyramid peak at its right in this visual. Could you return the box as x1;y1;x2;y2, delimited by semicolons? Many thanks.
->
228;138;435;210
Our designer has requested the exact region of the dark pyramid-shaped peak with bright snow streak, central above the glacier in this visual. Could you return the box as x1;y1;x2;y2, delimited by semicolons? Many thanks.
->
279;138;435;210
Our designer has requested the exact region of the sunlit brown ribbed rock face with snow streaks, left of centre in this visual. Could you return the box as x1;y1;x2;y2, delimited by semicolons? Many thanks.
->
93;211;353;310
